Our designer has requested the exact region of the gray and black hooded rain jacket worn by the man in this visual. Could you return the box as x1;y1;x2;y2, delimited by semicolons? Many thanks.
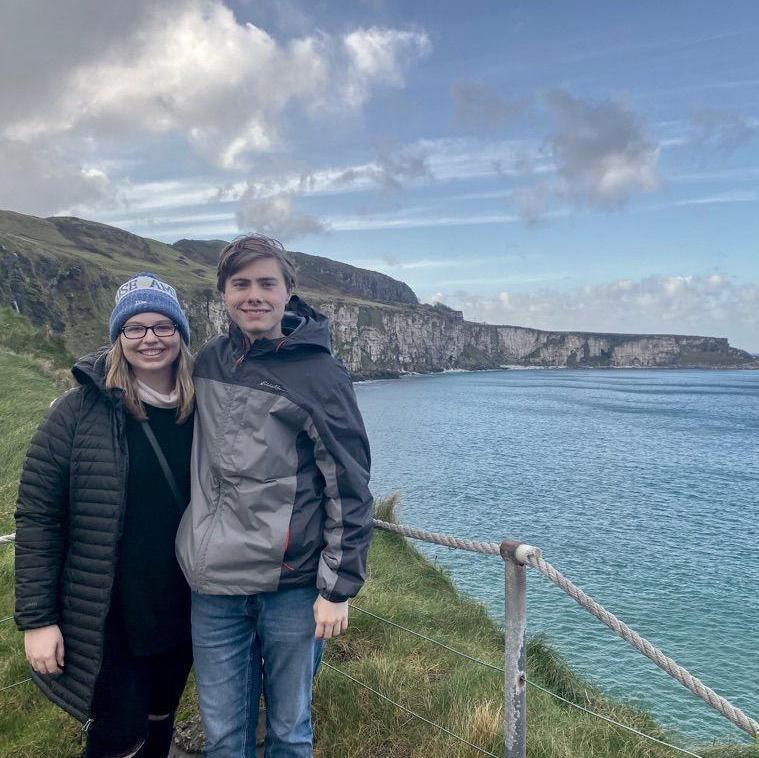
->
176;297;372;602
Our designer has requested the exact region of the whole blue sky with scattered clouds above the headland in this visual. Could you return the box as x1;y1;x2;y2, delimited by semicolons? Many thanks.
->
0;0;759;352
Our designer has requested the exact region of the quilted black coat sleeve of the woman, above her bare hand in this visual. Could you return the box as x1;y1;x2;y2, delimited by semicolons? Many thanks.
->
15;390;81;631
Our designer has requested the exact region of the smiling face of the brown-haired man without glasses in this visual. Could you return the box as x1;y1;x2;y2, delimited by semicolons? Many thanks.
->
221;258;290;341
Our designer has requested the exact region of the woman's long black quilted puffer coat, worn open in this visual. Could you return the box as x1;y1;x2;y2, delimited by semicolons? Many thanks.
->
15;353;128;722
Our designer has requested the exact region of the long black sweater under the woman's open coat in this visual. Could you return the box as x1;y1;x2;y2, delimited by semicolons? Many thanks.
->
111;405;193;655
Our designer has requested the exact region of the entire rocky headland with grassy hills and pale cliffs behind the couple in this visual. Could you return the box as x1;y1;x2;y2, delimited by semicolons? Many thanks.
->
0;211;759;379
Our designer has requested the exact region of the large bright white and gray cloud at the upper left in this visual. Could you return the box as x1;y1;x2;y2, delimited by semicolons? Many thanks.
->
0;0;431;214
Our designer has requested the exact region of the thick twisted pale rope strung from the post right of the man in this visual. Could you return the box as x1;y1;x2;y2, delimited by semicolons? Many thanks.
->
374;519;759;739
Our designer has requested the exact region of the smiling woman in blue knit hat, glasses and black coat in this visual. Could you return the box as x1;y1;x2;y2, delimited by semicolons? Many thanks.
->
15;272;194;758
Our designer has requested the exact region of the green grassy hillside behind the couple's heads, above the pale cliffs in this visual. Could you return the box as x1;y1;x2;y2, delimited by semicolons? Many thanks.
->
0;210;416;362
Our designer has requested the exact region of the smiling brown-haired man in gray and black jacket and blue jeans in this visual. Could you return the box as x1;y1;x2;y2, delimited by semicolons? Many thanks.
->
177;236;372;758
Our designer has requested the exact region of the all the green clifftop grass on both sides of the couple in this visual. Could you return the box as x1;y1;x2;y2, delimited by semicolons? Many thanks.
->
0;344;755;758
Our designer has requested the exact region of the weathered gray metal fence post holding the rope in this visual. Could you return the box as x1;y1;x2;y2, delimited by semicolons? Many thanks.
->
501;540;540;758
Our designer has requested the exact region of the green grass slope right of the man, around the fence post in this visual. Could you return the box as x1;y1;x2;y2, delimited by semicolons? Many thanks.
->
314;504;754;758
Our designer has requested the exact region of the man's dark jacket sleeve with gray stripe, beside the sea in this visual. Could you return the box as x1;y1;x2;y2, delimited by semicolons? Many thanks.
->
312;375;373;602
